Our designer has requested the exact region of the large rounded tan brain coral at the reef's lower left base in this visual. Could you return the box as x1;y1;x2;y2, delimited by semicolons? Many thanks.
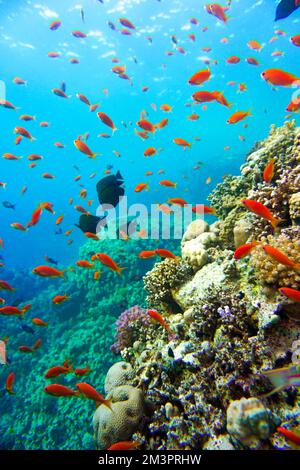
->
93;385;144;450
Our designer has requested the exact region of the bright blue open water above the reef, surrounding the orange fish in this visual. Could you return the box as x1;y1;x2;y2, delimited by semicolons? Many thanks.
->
0;0;300;447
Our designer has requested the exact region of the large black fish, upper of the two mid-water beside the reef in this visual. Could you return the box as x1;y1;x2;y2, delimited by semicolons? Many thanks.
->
96;171;125;207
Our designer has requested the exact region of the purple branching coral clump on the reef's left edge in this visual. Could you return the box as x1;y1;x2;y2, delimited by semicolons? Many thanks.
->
110;305;150;354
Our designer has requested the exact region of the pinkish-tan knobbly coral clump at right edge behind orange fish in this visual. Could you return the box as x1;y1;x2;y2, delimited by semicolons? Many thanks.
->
251;226;300;289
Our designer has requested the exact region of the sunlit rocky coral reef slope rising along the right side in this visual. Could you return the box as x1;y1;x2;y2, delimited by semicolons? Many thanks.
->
108;122;300;450
